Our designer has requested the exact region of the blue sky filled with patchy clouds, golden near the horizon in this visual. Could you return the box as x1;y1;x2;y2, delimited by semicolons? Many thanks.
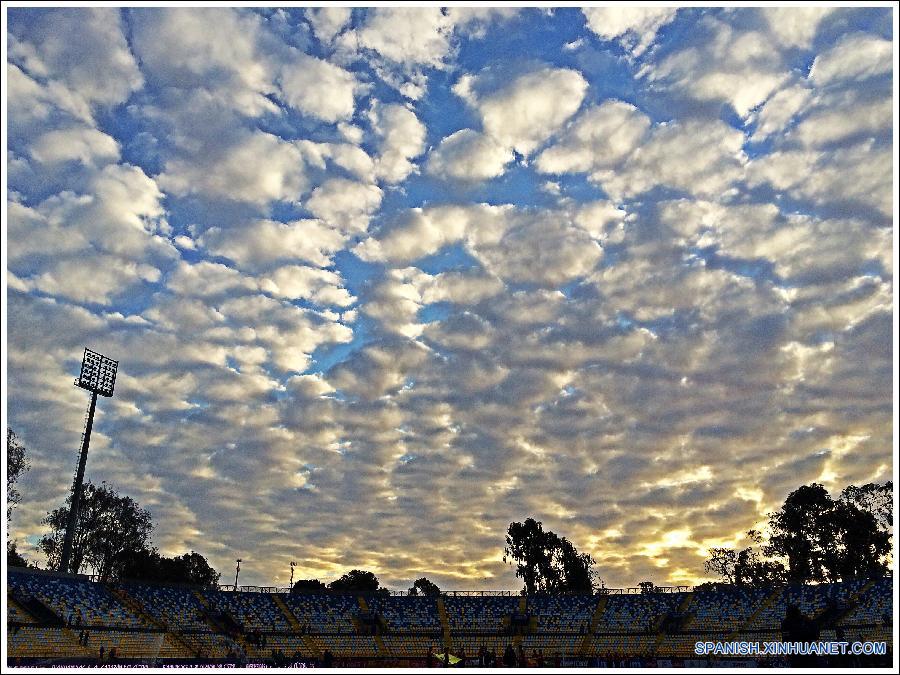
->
4;6;895;589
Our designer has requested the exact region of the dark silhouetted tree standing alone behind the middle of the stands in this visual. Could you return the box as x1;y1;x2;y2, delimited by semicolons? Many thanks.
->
503;518;595;595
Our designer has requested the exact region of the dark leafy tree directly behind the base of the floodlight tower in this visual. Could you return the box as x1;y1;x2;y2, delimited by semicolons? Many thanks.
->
40;481;153;581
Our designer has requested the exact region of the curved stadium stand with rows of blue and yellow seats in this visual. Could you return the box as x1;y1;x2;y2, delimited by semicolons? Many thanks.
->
6;568;893;666
